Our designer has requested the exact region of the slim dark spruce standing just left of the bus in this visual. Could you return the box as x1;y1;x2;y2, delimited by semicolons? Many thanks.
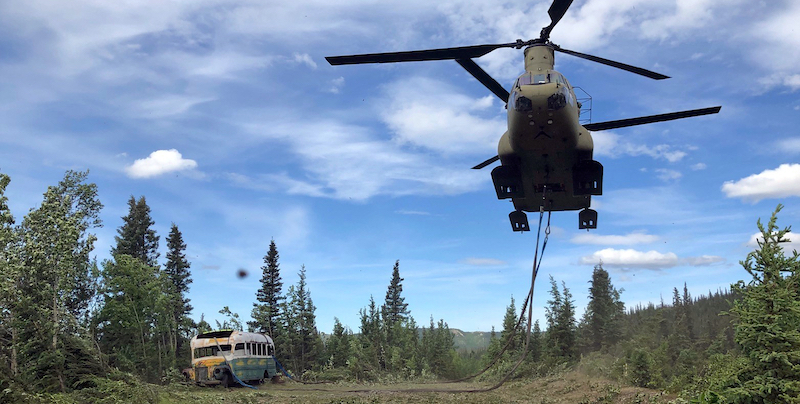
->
163;223;192;368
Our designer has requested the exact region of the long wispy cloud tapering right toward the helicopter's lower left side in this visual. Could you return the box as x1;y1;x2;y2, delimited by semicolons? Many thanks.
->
239;113;488;201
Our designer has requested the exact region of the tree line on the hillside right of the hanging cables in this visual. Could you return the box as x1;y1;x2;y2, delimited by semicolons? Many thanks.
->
484;205;800;403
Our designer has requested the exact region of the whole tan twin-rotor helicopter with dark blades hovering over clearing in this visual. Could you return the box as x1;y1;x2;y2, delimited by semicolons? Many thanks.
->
325;0;722;232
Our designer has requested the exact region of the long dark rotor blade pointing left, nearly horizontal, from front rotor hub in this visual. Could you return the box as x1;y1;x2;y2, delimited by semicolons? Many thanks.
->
325;41;523;66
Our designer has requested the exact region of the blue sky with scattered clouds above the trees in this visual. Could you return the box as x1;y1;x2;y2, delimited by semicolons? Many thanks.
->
0;0;800;332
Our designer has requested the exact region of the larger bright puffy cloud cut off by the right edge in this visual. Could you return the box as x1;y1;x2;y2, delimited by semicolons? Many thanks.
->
722;164;800;203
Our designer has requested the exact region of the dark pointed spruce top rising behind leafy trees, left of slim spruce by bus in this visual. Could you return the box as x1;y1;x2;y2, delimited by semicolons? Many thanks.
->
111;195;159;267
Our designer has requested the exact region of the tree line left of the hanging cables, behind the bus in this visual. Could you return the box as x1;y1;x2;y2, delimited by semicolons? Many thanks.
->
0;171;462;392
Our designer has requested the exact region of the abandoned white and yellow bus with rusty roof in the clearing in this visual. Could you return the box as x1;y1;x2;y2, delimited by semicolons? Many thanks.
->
183;330;277;387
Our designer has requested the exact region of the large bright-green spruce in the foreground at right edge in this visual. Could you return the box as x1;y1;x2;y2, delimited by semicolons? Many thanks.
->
724;205;800;403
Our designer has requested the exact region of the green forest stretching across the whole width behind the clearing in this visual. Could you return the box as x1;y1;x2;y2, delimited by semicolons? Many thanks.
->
0;171;800;403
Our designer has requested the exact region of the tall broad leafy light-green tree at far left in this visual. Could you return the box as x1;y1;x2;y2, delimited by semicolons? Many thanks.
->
15;171;102;391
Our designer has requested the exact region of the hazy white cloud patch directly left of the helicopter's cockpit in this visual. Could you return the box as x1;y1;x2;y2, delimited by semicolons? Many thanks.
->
381;77;506;155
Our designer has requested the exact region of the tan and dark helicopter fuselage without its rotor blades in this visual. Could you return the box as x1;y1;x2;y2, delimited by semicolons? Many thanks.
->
493;45;602;218
